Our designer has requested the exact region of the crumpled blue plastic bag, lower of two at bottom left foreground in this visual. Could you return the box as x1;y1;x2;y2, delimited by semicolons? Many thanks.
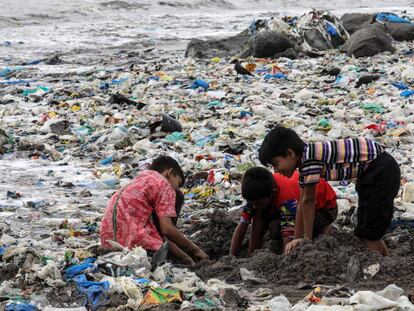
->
73;274;109;310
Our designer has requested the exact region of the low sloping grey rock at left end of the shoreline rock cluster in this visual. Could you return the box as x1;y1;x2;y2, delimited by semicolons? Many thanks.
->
185;29;250;58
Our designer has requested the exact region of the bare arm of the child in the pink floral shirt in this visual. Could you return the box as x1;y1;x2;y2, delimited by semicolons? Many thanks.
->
160;217;209;260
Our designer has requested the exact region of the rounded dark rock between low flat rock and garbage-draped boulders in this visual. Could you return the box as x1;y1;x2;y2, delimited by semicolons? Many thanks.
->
251;30;294;57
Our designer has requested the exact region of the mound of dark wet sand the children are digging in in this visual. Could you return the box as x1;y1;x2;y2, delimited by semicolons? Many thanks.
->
191;224;414;290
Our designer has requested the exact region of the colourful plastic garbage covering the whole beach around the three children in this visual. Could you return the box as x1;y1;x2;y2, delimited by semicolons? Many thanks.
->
0;6;414;311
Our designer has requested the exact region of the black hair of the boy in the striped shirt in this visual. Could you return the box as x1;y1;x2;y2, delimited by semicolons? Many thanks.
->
259;126;305;166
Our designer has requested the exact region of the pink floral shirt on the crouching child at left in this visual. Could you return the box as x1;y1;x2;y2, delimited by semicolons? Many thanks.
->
100;170;177;251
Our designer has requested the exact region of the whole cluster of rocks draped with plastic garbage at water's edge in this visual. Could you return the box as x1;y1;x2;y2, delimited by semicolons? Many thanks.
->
185;10;414;59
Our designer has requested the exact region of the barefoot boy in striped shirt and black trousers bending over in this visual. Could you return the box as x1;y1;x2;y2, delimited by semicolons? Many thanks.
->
259;127;401;256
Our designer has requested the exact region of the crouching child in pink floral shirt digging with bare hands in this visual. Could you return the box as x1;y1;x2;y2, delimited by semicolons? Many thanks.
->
100;156;208;264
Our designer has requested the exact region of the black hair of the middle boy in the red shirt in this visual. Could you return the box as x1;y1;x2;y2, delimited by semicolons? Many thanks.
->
242;166;277;201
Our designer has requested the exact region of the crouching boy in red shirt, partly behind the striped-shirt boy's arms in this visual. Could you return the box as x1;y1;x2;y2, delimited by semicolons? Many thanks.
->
230;167;338;256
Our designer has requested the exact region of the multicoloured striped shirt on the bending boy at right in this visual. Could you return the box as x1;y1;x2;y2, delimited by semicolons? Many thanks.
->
299;137;384;187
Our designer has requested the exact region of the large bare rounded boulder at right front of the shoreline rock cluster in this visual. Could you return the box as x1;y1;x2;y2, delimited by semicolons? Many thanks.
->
343;26;395;57
